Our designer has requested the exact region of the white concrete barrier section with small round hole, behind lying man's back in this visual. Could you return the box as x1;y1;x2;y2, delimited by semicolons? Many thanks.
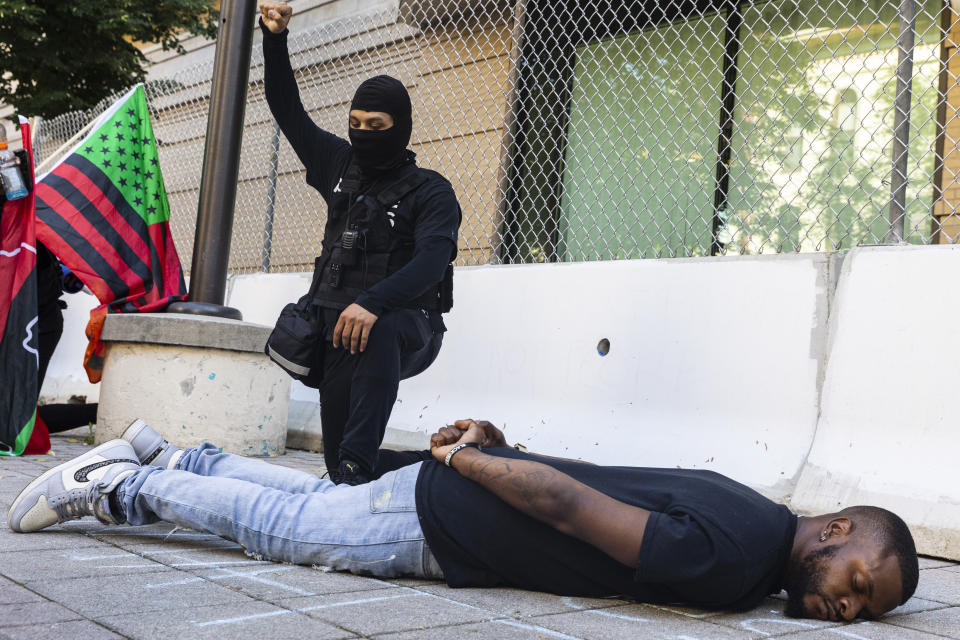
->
382;254;830;498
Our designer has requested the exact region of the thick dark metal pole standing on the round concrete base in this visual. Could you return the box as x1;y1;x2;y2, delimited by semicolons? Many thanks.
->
182;0;256;316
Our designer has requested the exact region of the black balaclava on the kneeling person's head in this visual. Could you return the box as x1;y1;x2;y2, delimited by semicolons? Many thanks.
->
350;76;413;175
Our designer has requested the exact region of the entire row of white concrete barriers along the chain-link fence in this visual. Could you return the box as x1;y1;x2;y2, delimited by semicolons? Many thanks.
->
44;246;960;559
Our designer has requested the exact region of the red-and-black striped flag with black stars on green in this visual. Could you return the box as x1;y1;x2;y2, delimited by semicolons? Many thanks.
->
36;85;187;382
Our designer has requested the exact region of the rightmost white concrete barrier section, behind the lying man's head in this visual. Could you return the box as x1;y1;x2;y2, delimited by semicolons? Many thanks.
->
792;246;960;559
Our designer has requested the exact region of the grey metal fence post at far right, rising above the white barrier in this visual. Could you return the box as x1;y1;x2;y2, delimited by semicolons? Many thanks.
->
887;0;917;244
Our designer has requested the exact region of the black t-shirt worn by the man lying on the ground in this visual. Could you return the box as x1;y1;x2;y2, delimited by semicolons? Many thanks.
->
416;449;797;609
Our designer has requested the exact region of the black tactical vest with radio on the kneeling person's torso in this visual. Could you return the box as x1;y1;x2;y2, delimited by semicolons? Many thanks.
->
313;165;453;313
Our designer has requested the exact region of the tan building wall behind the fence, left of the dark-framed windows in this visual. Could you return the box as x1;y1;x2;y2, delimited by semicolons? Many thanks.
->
150;0;511;273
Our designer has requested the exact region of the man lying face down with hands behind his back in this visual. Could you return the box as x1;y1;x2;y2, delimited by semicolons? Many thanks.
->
7;420;919;620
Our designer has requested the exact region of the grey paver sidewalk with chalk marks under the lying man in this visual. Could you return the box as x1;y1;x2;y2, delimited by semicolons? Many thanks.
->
0;431;960;640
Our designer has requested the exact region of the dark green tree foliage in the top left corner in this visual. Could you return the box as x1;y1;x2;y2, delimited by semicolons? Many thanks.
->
0;0;219;118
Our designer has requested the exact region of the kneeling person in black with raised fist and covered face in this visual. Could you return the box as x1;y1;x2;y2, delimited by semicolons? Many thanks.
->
260;2;461;484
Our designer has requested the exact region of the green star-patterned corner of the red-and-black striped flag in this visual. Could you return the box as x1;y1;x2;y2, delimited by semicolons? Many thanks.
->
77;92;169;224
